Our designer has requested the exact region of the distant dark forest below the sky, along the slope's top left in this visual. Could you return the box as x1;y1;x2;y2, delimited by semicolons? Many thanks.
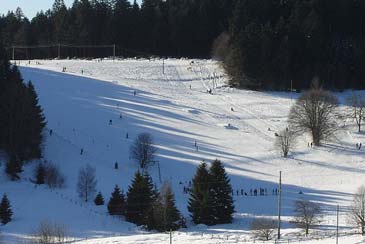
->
0;0;234;58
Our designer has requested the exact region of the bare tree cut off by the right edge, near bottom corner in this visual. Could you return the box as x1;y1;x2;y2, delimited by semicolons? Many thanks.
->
348;186;365;235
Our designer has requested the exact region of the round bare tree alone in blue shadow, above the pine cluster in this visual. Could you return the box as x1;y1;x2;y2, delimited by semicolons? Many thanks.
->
130;133;157;169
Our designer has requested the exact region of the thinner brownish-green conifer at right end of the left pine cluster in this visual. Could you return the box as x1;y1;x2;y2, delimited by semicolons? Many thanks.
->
153;183;181;231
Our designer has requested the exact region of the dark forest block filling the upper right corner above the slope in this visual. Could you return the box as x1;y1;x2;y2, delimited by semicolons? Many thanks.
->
220;0;365;90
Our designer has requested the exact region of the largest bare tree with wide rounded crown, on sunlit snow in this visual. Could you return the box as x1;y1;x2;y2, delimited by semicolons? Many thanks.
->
289;88;339;146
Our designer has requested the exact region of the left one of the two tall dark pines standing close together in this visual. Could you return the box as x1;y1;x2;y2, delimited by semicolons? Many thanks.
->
188;162;214;225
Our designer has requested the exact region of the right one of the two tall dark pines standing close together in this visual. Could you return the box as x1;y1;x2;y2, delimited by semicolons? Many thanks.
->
209;159;234;224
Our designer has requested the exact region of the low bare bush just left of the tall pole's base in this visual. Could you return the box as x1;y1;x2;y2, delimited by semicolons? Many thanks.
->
251;218;277;241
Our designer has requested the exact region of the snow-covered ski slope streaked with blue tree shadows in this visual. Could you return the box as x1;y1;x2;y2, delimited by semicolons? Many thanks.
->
0;59;365;243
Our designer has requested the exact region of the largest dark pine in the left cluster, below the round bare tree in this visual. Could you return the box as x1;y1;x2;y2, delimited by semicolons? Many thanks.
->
126;171;157;226
